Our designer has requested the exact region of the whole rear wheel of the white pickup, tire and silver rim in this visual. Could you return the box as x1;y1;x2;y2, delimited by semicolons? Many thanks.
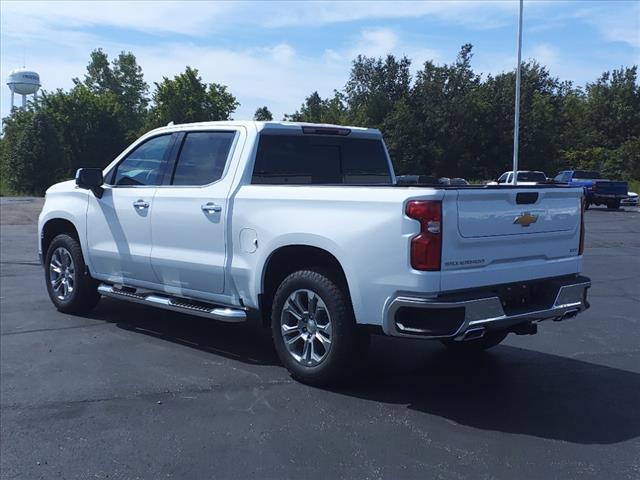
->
271;270;367;386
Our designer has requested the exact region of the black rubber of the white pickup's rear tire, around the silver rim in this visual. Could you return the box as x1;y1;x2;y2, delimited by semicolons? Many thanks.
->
271;270;369;386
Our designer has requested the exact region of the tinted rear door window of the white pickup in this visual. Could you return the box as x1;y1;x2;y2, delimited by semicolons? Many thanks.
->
171;132;235;186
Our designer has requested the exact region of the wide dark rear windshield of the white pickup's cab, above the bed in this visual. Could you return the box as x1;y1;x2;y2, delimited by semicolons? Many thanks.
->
252;135;391;185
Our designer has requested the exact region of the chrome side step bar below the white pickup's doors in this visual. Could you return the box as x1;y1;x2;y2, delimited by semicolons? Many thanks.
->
98;283;247;323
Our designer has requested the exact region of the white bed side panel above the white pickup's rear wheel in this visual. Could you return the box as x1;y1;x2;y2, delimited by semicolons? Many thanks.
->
231;185;443;324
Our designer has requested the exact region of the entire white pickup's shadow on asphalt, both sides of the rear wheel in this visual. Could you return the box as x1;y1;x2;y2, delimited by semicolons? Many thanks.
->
94;301;640;444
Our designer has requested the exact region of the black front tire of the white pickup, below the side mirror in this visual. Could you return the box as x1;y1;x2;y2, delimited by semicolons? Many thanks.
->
44;233;100;314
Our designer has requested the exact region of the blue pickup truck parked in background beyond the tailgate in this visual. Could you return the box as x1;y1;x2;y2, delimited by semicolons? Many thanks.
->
554;170;628;208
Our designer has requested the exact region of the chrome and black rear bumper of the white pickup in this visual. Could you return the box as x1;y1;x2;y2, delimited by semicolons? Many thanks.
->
384;276;591;339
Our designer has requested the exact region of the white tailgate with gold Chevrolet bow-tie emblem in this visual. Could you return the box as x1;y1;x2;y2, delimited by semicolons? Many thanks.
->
441;186;582;290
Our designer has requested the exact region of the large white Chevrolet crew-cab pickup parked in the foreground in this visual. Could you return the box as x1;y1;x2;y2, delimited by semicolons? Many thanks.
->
38;121;590;384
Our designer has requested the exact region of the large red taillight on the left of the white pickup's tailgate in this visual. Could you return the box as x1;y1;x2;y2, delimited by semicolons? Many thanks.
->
406;200;442;271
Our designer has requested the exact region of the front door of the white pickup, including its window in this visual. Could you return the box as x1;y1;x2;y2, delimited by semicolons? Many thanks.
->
87;134;174;284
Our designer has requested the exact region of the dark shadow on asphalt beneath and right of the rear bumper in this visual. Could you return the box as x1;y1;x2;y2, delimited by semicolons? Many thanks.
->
339;339;640;444
